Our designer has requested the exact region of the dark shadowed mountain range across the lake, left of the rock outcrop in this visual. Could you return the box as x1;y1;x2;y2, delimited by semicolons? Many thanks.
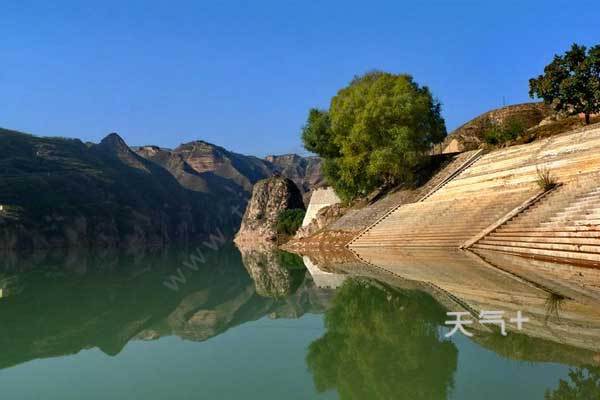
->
0;129;324;249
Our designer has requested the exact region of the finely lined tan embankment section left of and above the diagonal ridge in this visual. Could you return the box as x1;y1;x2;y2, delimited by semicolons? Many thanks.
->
350;125;600;252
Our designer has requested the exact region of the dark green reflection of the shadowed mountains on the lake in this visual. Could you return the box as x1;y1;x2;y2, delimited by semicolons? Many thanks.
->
0;248;329;368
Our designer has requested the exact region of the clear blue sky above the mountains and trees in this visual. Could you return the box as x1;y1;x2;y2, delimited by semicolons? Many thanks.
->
0;0;600;156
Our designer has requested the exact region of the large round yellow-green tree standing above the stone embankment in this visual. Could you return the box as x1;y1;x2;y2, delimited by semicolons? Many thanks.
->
302;71;446;200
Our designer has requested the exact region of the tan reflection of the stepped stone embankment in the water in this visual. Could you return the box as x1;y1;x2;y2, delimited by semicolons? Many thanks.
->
356;248;600;358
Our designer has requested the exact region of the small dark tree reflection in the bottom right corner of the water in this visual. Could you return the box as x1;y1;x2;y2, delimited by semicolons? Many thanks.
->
545;367;600;400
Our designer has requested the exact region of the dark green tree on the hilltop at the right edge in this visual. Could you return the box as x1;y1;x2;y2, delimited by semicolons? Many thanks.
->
529;44;600;124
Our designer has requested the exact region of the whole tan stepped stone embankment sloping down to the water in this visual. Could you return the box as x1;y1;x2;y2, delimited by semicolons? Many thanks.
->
350;126;600;253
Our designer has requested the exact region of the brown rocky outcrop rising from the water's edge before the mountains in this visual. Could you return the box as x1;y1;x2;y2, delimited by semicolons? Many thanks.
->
235;176;304;243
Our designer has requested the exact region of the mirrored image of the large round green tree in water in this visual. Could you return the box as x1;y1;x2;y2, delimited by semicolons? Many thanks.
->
307;280;458;400
